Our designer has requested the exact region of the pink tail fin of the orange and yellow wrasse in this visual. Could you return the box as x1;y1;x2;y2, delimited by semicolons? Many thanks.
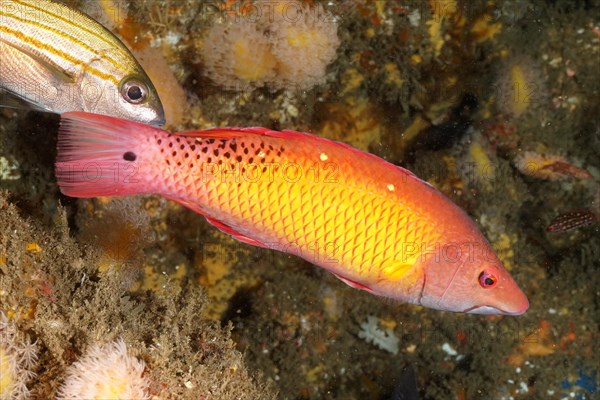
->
56;112;160;197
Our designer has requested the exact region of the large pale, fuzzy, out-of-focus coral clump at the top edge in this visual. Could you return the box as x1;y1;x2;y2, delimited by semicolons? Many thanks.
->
197;1;340;89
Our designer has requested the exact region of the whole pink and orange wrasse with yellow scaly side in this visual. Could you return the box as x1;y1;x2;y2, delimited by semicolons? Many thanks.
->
56;112;529;315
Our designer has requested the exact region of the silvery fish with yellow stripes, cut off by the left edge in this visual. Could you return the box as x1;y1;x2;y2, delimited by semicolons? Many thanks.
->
0;0;165;126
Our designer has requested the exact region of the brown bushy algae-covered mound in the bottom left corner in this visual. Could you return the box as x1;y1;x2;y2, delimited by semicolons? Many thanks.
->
0;192;276;399
